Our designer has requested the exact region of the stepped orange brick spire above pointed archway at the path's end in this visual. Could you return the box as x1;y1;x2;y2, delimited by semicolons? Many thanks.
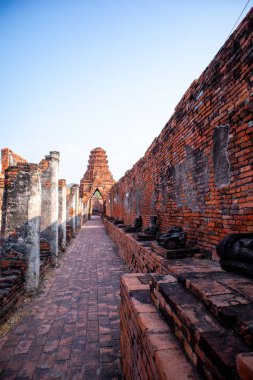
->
80;148;115;203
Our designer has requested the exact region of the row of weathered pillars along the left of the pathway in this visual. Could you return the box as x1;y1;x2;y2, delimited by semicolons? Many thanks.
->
0;152;83;292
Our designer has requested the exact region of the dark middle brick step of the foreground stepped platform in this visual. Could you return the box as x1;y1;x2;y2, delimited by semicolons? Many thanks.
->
150;275;250;379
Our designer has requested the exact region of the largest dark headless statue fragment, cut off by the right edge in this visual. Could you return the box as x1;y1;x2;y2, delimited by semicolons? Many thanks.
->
216;233;253;277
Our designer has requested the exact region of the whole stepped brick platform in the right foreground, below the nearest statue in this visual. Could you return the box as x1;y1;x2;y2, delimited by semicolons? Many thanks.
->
121;266;253;379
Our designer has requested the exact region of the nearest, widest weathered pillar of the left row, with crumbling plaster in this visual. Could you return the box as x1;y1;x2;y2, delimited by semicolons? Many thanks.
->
1;163;41;292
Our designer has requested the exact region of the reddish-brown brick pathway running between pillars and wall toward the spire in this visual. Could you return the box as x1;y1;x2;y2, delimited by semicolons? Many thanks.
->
0;217;126;380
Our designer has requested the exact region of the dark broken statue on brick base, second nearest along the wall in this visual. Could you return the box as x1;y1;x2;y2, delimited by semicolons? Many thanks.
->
157;226;187;250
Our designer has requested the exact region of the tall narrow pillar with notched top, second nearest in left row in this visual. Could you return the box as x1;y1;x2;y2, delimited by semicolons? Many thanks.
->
40;152;60;265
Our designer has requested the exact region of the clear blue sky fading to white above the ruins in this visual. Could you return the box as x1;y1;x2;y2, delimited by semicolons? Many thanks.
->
0;0;252;183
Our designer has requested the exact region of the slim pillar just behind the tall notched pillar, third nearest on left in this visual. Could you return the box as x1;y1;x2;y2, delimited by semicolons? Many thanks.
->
58;179;67;251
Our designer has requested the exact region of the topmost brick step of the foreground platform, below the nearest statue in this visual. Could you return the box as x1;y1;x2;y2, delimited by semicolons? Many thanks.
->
178;271;253;349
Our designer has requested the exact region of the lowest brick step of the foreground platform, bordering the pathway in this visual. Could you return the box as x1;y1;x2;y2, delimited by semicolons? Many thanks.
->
120;273;202;380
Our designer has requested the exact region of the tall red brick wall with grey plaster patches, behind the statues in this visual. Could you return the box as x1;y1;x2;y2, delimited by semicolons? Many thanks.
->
107;9;253;254
